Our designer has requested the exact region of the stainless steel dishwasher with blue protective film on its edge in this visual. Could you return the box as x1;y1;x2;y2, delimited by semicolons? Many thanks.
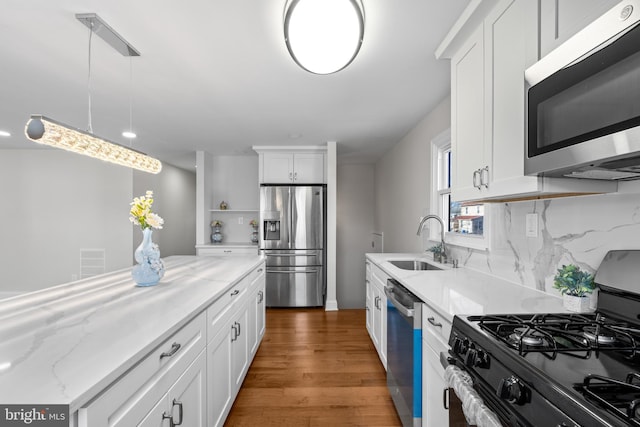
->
384;279;422;427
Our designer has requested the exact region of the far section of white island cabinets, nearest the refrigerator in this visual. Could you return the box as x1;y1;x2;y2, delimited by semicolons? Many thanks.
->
207;267;265;427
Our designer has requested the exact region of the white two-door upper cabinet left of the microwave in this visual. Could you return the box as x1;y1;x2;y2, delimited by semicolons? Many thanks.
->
436;0;615;201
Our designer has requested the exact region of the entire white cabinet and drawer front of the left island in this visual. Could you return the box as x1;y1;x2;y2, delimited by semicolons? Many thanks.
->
77;263;265;427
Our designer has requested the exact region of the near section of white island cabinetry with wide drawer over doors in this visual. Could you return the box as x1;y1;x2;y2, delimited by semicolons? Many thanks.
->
78;313;207;427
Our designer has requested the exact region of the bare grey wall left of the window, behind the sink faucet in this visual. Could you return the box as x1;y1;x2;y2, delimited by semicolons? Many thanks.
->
375;97;451;252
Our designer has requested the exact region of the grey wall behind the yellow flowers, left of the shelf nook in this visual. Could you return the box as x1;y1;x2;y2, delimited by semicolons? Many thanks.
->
131;163;196;257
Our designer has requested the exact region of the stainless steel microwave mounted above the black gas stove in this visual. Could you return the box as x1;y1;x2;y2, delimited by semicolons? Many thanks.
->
525;0;640;180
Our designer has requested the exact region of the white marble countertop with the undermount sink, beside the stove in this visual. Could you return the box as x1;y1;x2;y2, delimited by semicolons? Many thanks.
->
366;253;567;322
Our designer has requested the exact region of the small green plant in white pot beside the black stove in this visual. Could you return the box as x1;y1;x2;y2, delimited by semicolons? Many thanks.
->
553;264;595;312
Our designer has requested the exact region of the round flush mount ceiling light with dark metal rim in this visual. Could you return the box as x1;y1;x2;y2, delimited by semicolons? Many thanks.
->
284;0;364;74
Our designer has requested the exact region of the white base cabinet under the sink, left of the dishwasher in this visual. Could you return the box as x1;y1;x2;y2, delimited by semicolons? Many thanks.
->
366;262;389;369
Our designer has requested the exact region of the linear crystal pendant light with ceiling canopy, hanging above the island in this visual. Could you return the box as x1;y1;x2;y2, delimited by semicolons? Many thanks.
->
25;13;162;174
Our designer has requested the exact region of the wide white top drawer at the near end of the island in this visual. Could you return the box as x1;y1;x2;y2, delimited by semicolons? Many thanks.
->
78;312;207;427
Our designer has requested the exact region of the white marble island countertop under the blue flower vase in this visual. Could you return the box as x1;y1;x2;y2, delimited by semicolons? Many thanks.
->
0;256;263;413
